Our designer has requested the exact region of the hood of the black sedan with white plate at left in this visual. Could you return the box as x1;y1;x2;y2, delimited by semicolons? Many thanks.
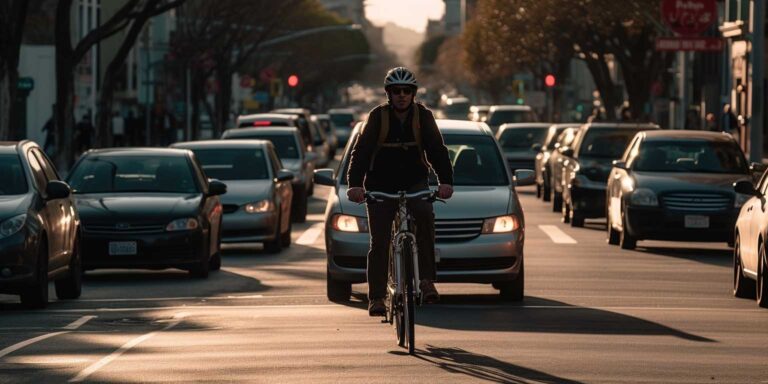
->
75;193;203;224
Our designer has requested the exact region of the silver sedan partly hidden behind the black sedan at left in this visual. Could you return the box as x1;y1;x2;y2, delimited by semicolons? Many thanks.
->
172;140;293;253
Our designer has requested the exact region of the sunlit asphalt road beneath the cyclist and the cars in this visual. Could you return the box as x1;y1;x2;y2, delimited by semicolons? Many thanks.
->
0;176;768;384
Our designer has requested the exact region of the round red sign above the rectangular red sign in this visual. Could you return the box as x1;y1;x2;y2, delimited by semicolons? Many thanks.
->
661;0;717;36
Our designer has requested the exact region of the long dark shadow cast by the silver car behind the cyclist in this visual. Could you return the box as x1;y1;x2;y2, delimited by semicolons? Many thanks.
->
416;295;715;343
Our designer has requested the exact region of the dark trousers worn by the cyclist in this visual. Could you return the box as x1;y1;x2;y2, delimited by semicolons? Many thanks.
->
366;186;436;300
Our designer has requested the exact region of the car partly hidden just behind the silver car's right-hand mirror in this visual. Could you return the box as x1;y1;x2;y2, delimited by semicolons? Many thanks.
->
496;123;552;172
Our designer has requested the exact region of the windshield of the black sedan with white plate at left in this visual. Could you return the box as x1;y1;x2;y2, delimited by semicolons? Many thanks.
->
68;155;199;193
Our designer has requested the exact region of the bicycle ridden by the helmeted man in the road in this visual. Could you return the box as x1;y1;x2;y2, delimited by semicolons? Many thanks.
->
365;190;442;355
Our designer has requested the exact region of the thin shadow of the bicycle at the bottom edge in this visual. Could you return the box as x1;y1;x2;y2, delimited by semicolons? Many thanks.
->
404;345;579;384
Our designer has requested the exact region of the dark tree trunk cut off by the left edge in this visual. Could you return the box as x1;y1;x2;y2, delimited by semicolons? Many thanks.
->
0;0;28;140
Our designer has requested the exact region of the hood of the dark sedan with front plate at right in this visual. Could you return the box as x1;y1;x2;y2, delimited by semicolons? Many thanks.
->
632;172;751;194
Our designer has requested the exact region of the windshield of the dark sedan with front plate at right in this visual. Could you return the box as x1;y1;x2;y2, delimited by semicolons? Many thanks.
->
632;140;748;173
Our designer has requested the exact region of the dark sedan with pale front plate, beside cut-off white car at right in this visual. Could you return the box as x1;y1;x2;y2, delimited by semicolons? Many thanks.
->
606;130;751;249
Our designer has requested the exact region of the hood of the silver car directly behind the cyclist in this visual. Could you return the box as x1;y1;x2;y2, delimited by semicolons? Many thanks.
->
339;186;512;220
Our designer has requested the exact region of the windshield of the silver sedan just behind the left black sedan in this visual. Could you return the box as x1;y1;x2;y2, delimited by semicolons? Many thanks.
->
192;148;269;180
